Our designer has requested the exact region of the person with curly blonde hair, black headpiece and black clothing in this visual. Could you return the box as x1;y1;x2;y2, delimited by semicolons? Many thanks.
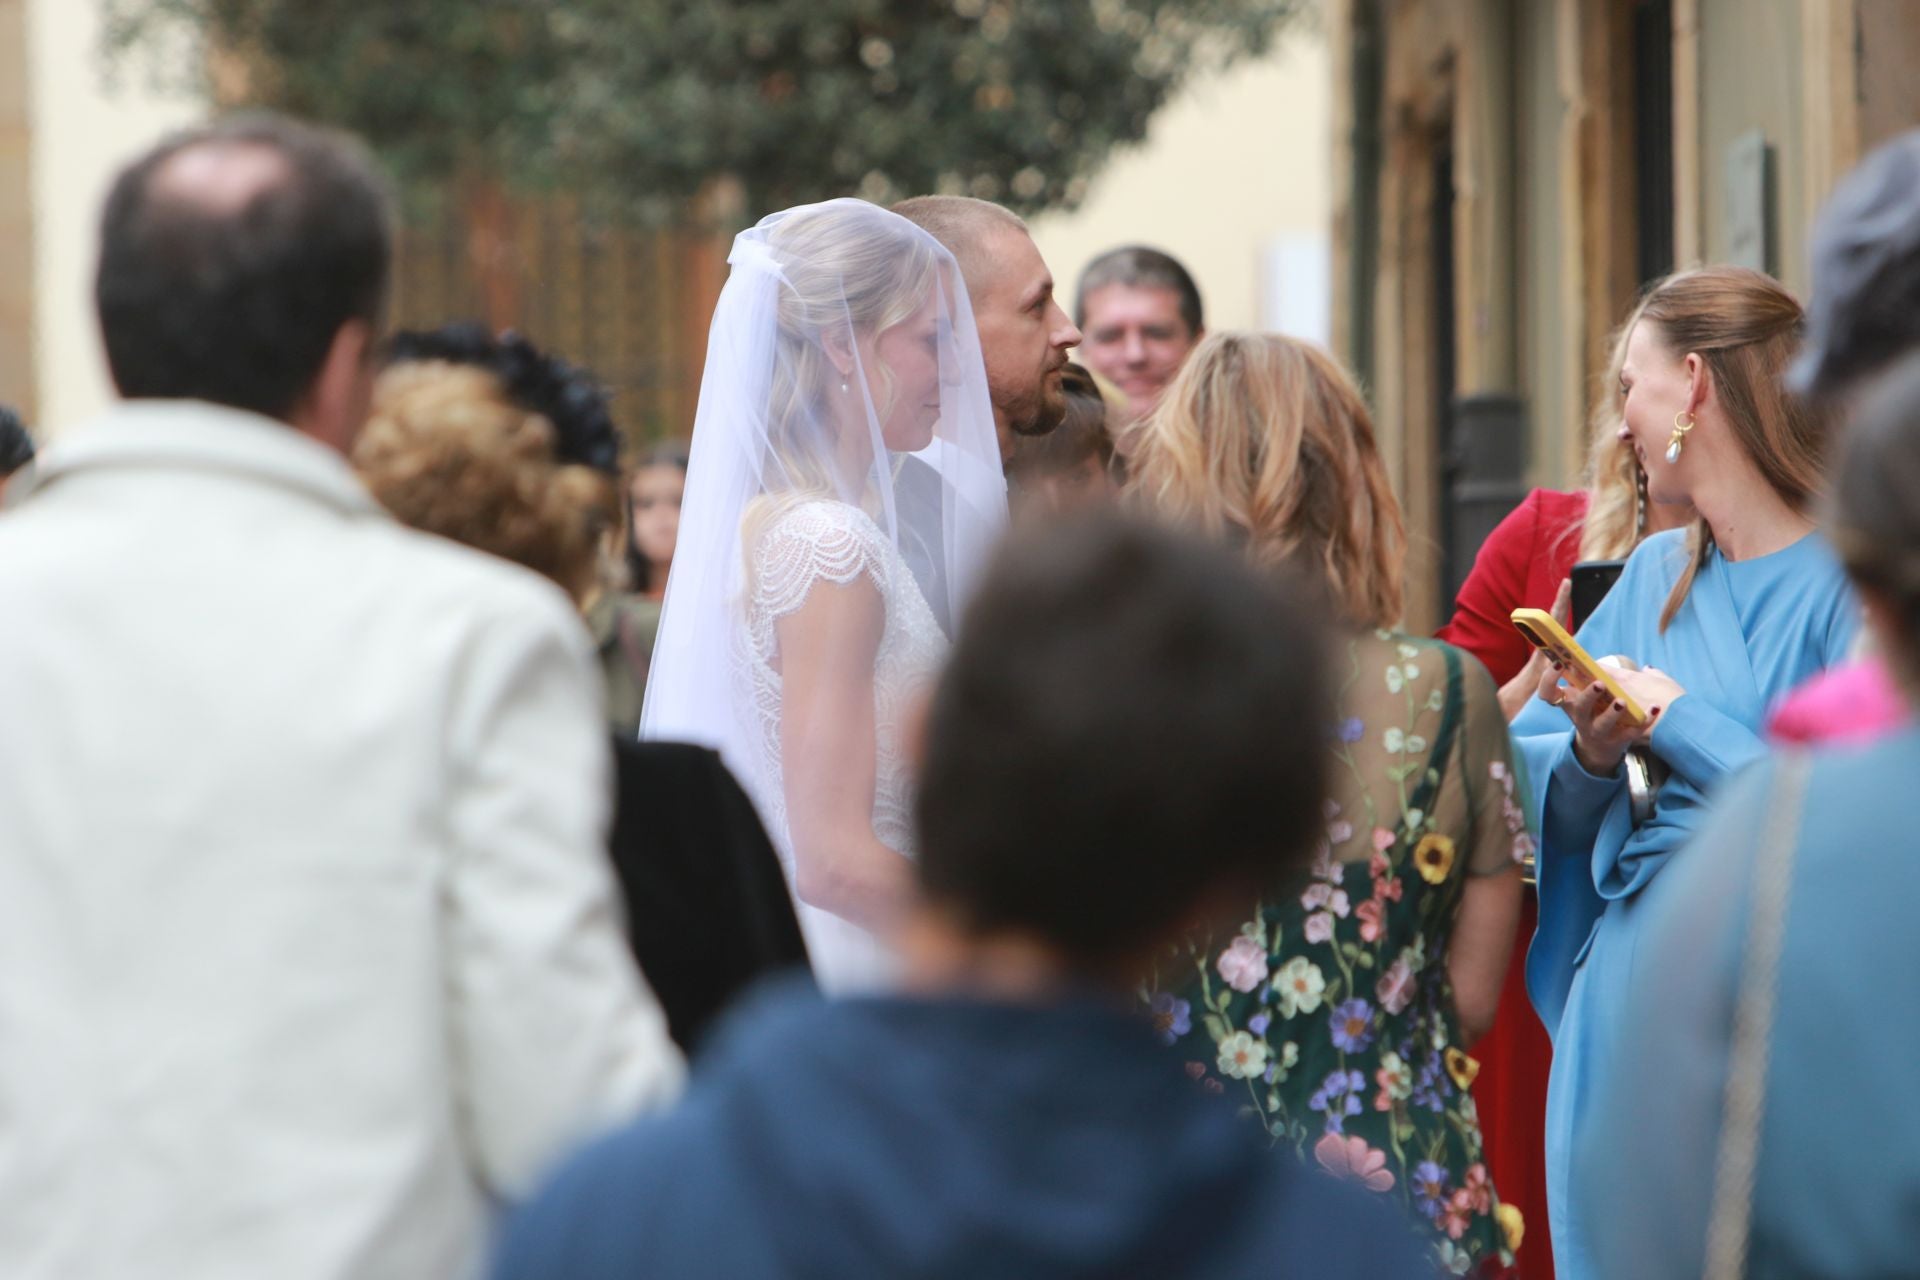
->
353;324;806;1048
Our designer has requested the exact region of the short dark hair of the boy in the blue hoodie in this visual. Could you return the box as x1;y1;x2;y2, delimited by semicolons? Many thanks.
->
918;512;1332;977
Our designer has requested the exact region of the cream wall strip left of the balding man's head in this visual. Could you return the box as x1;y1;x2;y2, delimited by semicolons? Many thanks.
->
22;0;204;436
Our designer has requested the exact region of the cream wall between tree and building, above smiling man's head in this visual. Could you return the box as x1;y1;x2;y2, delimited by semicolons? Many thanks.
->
1033;25;1332;339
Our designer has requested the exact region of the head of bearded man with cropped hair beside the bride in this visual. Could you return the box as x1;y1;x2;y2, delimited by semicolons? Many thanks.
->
893;196;1081;462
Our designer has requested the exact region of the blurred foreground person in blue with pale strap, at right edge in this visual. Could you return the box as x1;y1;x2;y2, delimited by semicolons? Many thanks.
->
1574;357;1920;1280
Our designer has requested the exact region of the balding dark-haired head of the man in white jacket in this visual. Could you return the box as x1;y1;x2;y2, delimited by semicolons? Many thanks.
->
94;115;392;420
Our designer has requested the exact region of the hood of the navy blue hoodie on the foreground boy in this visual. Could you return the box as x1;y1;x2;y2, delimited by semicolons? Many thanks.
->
705;992;1302;1278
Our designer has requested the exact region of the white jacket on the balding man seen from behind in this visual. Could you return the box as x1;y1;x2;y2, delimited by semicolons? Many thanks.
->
0;401;682;1280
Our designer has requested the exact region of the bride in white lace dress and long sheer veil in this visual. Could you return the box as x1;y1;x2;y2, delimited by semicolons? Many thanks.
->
641;200;1006;992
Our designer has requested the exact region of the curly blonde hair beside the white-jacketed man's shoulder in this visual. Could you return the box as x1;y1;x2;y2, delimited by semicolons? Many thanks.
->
351;361;620;606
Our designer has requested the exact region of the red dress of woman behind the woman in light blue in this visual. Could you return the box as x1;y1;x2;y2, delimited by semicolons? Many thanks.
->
1440;489;1586;1280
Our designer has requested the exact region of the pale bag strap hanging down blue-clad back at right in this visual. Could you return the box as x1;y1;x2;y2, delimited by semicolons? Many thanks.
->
1705;750;1812;1280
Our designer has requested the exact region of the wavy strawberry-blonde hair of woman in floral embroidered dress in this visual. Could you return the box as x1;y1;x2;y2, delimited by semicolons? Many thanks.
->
1133;332;1407;628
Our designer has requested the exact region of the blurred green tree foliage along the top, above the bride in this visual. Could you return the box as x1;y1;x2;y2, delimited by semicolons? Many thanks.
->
106;0;1306;213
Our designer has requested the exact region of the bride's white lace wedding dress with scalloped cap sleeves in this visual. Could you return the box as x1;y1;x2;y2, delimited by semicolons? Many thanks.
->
733;499;947;992
